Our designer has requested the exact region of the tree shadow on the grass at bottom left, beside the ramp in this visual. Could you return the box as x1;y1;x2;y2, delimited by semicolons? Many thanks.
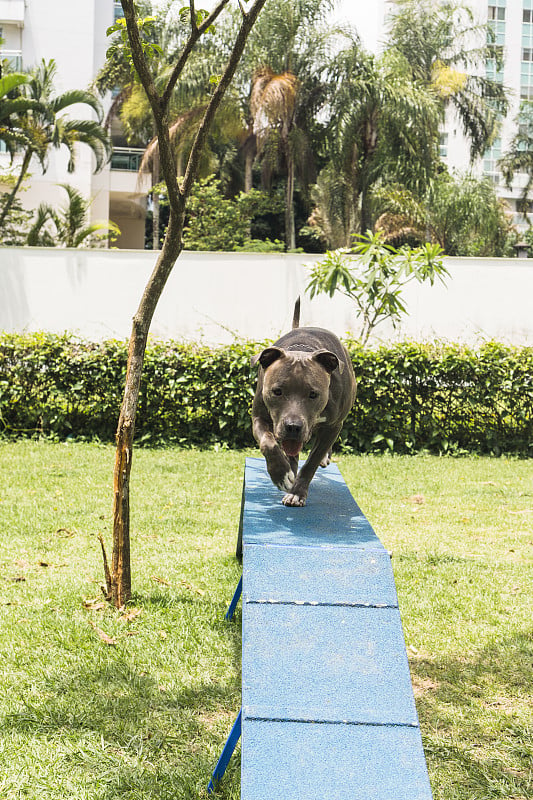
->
0;591;241;800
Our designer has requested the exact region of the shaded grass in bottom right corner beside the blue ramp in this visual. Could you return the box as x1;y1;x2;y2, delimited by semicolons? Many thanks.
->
410;630;533;800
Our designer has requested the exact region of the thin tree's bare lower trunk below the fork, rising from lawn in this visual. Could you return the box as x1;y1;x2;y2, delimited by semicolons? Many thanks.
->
107;212;183;608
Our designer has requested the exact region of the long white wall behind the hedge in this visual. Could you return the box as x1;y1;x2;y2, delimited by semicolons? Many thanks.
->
0;248;533;345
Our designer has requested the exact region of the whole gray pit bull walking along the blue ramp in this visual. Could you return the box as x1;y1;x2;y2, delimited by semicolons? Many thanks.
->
252;300;356;506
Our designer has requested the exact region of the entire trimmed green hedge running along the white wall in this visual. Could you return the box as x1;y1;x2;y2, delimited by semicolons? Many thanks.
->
0;334;533;456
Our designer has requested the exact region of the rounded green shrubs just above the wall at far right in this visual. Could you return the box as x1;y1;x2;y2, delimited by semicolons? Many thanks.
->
374;172;512;256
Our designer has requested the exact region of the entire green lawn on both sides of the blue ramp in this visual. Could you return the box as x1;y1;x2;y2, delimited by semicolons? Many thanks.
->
0;442;533;800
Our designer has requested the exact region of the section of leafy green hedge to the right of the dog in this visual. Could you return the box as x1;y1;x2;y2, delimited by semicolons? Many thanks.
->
342;342;533;456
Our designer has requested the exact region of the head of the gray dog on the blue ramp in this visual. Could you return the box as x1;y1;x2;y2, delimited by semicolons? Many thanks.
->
252;347;344;457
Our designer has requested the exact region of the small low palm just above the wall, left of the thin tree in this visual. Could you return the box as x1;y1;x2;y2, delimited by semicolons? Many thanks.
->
26;183;120;247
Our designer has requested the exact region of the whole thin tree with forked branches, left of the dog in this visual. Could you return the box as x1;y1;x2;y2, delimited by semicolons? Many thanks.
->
104;0;266;608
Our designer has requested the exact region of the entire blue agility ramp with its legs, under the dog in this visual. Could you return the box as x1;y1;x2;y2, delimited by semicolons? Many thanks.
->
209;459;432;800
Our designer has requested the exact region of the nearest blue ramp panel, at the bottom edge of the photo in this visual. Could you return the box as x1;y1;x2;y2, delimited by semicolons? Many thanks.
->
241;717;431;800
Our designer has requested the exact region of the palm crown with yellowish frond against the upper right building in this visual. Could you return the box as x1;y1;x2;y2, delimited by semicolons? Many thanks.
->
389;0;508;160
